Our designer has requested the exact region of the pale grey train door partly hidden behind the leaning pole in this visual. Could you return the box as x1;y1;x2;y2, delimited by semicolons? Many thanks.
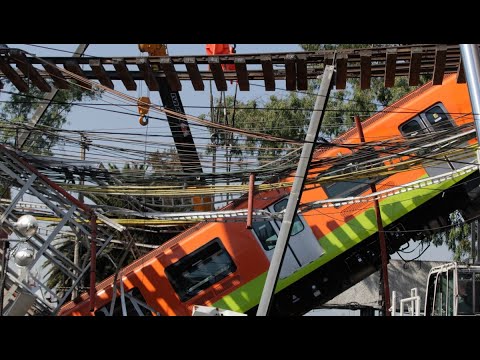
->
249;198;324;279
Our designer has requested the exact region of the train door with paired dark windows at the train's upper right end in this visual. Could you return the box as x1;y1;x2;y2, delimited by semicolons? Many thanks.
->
400;103;476;176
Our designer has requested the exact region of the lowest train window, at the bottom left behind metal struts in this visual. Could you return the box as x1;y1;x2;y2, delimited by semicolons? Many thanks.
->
95;288;160;316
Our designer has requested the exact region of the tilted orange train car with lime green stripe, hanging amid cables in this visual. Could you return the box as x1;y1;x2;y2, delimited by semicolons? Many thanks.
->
59;75;479;315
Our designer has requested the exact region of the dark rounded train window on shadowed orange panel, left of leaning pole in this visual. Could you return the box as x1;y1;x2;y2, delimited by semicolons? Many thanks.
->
165;238;237;301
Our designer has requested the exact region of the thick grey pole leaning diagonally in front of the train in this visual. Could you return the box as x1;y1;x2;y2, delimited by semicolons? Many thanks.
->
257;65;334;316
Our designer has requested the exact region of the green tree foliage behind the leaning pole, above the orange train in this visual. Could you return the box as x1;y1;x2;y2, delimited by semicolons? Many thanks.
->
203;44;427;164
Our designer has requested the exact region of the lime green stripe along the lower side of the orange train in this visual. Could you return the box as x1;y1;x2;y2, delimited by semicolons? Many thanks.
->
213;173;470;312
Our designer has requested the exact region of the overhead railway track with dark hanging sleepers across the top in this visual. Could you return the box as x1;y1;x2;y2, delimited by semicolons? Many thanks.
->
0;44;465;92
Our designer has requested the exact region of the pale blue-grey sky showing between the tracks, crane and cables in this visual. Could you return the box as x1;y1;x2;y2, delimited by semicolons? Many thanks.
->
0;44;453;260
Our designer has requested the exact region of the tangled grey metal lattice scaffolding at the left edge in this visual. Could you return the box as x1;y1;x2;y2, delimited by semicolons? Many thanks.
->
0;144;127;315
